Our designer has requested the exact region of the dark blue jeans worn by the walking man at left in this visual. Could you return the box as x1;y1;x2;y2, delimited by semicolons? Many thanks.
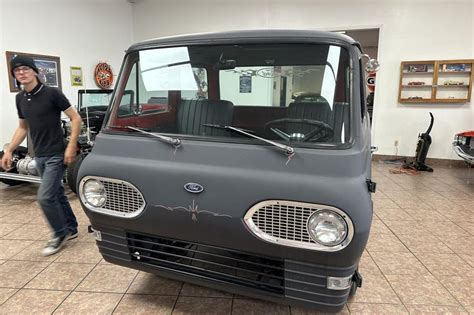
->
35;154;77;237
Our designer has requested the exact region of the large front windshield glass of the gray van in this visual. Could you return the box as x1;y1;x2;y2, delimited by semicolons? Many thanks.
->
106;44;351;146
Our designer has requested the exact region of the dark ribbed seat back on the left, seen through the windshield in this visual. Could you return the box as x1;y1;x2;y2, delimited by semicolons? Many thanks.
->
177;99;234;136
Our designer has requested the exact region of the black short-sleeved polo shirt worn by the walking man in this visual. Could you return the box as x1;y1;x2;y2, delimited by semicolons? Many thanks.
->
16;83;71;156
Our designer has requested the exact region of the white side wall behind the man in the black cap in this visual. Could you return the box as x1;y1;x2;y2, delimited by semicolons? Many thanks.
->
0;0;133;146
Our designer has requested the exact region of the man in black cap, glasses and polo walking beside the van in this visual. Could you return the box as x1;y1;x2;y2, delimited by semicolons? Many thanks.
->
2;55;81;256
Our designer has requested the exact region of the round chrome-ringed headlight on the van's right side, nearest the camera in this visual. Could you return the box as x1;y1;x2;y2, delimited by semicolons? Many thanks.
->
307;209;347;246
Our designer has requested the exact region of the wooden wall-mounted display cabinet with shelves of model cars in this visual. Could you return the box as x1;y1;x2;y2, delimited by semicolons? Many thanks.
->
398;59;474;103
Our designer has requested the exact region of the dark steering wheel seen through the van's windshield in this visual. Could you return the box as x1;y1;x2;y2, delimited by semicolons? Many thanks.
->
265;118;334;142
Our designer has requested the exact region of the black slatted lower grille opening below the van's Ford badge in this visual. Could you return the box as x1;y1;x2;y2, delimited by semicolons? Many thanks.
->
127;233;285;295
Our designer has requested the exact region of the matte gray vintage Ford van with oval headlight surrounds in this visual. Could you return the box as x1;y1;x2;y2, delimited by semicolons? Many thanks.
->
78;30;377;311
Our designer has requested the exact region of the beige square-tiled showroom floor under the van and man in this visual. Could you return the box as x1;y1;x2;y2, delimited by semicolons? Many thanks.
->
0;162;474;314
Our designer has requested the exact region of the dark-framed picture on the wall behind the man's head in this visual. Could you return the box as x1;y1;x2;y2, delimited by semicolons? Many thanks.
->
5;51;62;92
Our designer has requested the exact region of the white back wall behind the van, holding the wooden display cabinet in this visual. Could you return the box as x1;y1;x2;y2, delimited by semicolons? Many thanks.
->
133;0;474;159
